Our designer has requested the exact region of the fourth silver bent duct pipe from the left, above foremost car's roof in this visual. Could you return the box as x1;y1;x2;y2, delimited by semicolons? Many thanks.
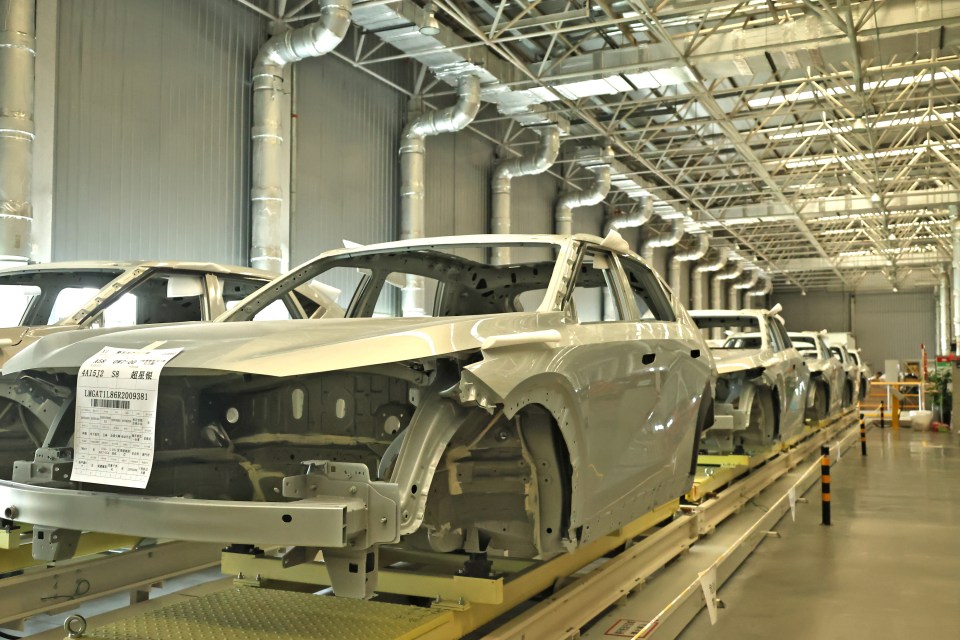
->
490;125;560;264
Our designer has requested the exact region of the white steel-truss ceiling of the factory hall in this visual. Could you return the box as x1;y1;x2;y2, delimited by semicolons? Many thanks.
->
238;0;960;292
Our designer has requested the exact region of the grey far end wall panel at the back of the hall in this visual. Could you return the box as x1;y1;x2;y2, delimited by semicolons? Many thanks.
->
853;292;936;371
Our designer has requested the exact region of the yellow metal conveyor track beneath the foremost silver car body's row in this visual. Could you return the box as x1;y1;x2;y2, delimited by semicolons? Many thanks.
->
28;411;856;640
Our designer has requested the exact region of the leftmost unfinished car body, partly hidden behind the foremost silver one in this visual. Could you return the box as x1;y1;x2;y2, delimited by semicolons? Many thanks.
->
0;261;334;479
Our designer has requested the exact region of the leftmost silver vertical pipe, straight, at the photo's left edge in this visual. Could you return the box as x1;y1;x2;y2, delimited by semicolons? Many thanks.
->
0;0;37;262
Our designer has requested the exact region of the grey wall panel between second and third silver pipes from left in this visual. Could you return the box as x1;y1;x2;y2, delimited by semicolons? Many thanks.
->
290;56;404;265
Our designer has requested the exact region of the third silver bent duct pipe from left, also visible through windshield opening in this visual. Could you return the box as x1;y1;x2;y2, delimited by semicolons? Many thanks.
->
400;75;480;317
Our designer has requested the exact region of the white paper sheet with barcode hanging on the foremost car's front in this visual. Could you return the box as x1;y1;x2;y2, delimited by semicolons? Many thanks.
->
70;347;181;489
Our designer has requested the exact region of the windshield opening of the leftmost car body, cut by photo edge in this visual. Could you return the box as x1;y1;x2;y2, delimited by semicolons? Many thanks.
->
0;269;122;327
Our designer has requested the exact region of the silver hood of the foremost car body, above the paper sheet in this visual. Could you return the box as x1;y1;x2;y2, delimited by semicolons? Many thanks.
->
3;313;562;376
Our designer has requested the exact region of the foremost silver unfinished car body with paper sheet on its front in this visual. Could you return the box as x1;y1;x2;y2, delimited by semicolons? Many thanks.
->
0;233;716;597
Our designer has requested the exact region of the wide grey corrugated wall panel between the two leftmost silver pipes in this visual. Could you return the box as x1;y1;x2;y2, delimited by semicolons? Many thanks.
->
53;0;265;264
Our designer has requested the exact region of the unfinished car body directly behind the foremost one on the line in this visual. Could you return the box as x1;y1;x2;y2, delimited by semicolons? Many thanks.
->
690;305;810;453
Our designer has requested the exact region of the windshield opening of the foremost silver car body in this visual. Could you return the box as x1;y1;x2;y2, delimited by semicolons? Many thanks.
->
223;243;560;321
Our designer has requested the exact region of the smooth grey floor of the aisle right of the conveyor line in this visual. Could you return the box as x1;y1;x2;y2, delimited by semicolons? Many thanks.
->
680;429;960;640
